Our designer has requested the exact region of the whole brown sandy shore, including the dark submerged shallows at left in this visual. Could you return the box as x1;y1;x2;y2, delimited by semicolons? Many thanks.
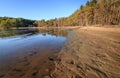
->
0;26;120;78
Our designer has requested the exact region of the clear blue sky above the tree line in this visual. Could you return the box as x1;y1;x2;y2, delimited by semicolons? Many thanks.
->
0;0;87;20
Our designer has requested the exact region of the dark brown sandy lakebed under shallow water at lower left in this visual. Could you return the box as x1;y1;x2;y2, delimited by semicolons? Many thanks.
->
0;47;59;78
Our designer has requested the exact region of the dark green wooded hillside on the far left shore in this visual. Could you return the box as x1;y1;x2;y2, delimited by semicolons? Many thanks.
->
0;17;34;29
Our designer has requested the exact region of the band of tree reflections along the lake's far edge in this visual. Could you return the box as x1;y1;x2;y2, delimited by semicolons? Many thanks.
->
0;28;67;39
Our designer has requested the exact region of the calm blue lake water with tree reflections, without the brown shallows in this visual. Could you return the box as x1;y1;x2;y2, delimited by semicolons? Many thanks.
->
0;29;68;67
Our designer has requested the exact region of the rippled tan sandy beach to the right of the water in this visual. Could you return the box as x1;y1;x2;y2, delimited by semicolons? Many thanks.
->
51;27;120;78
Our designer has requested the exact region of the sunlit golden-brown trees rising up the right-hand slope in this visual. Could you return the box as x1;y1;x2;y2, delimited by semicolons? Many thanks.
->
37;0;120;27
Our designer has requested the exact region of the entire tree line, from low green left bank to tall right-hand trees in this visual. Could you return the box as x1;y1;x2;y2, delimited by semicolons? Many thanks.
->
0;0;120;28
